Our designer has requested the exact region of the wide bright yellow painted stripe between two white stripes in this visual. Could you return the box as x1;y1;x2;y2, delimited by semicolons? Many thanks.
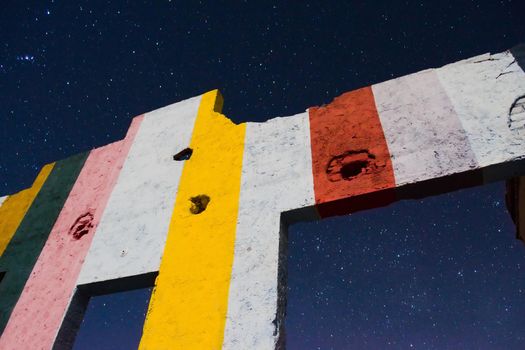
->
139;90;246;350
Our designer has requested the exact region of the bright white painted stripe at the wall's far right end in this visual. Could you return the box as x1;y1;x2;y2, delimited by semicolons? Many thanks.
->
437;52;525;176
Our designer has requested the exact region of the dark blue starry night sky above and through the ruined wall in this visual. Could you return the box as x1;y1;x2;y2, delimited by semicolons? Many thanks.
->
0;0;525;349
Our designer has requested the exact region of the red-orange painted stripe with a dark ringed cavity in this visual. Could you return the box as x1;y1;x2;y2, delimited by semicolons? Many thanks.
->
309;87;395;217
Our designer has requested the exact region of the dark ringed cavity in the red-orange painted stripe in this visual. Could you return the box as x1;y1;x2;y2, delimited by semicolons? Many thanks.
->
326;150;376;182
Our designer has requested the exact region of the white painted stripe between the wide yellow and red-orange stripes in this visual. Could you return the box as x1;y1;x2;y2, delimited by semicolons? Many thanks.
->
223;113;315;349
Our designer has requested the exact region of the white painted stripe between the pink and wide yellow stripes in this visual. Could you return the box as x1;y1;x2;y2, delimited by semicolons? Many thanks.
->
78;96;201;284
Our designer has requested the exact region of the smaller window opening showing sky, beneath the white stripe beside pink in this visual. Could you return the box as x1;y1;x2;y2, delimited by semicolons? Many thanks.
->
73;288;152;350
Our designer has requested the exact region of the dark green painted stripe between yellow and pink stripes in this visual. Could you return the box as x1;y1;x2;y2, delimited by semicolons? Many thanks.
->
0;152;89;332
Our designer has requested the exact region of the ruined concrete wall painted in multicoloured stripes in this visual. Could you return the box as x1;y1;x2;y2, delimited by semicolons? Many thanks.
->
0;47;525;350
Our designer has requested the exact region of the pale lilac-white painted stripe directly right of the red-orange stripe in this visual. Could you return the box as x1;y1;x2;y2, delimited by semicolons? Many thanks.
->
372;70;476;186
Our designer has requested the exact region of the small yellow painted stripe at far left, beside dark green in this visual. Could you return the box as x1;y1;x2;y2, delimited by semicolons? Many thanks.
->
0;163;55;256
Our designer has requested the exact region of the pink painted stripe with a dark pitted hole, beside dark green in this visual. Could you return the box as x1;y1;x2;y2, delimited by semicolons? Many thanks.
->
0;116;143;349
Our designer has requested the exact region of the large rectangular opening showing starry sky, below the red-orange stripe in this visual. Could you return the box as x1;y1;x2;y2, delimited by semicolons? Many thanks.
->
285;183;525;349
